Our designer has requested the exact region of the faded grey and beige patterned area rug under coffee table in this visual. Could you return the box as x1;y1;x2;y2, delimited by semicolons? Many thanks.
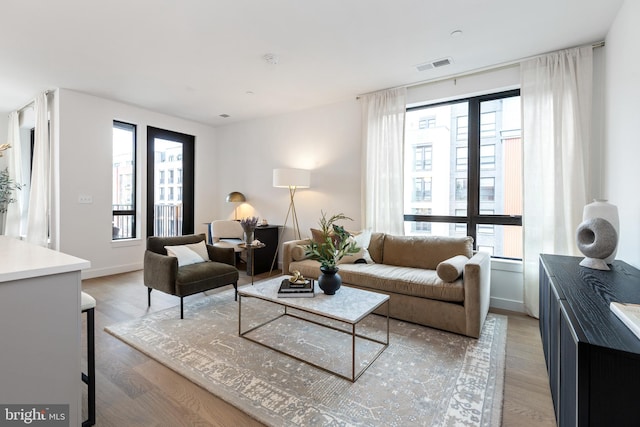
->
105;290;507;426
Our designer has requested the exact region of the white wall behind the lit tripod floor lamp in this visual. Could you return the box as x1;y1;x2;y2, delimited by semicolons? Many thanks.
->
215;99;362;246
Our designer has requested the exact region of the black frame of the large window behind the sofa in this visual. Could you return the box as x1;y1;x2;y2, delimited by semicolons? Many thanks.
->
404;89;522;259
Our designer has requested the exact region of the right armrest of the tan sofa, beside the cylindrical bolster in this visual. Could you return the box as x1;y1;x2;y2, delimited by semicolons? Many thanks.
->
463;252;491;338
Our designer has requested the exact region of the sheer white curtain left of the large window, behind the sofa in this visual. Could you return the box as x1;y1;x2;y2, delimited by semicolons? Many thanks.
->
362;88;407;235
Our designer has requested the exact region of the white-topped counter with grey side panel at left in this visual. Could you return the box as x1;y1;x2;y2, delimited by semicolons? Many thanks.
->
0;236;90;426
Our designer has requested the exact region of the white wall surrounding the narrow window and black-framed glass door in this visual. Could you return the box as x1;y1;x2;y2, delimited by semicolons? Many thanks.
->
58;89;216;278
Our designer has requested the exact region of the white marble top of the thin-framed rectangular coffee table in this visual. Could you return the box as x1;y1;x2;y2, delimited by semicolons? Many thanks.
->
238;276;389;324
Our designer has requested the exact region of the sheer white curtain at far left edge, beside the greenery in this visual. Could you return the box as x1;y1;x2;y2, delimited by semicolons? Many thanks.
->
4;111;23;237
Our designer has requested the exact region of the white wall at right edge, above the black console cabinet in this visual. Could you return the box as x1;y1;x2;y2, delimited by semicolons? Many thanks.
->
604;0;640;268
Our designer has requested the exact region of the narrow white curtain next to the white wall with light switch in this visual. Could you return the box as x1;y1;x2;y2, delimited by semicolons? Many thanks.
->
26;92;51;247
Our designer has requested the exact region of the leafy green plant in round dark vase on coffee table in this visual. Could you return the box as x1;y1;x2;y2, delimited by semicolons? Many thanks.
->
305;211;360;295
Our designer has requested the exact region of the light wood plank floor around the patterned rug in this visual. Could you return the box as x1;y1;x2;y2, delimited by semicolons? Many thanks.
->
82;271;556;427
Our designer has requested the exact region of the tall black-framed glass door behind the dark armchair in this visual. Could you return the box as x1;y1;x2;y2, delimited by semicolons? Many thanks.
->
147;126;195;236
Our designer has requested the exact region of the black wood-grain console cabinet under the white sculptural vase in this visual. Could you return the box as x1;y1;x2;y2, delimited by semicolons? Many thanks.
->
540;255;640;427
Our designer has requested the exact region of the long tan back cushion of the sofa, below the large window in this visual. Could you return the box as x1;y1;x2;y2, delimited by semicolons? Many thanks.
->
380;234;473;270
